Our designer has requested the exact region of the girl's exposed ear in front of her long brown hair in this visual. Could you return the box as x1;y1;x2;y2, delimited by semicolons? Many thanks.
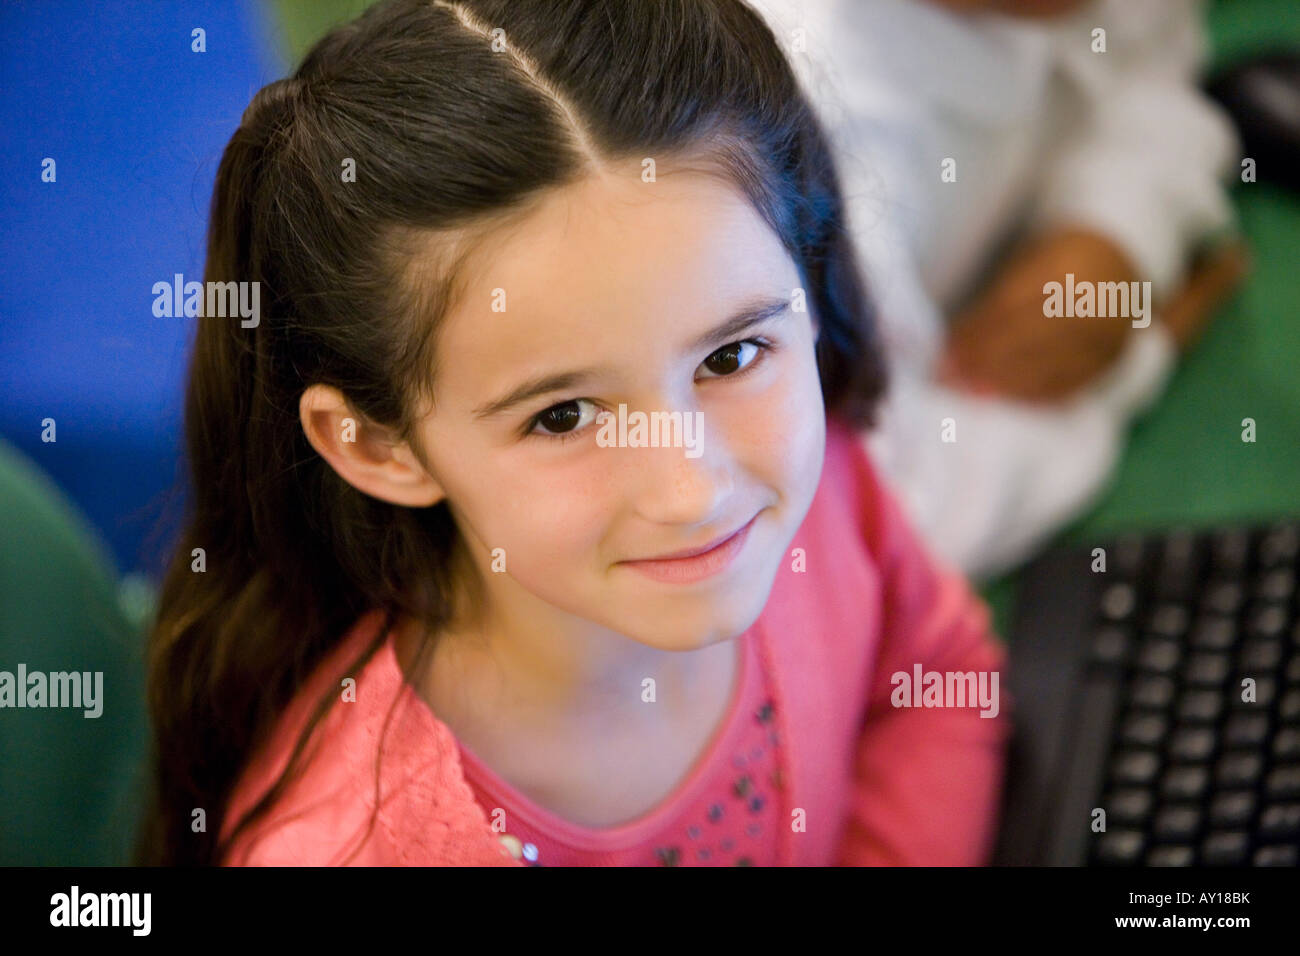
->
298;385;446;507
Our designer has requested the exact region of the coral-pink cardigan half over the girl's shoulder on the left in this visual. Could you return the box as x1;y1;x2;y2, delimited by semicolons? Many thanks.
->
222;611;515;866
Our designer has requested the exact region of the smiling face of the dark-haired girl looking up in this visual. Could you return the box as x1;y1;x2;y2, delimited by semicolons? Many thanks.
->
403;164;826;650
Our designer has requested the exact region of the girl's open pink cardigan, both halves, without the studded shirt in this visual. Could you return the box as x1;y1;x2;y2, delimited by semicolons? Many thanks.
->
221;419;1011;866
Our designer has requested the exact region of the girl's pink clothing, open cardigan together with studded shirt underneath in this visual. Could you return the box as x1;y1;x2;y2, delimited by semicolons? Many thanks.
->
221;419;1011;866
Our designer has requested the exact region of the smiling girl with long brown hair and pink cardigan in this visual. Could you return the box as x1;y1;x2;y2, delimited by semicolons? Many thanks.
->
140;0;1009;865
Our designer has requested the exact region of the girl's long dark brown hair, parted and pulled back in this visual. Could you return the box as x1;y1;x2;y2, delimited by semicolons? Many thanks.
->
137;0;884;865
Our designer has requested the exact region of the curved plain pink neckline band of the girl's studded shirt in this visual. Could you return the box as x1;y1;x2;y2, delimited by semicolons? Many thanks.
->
456;622;758;851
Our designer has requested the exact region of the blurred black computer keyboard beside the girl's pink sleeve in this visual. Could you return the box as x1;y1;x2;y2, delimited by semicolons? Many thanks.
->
995;522;1300;866
